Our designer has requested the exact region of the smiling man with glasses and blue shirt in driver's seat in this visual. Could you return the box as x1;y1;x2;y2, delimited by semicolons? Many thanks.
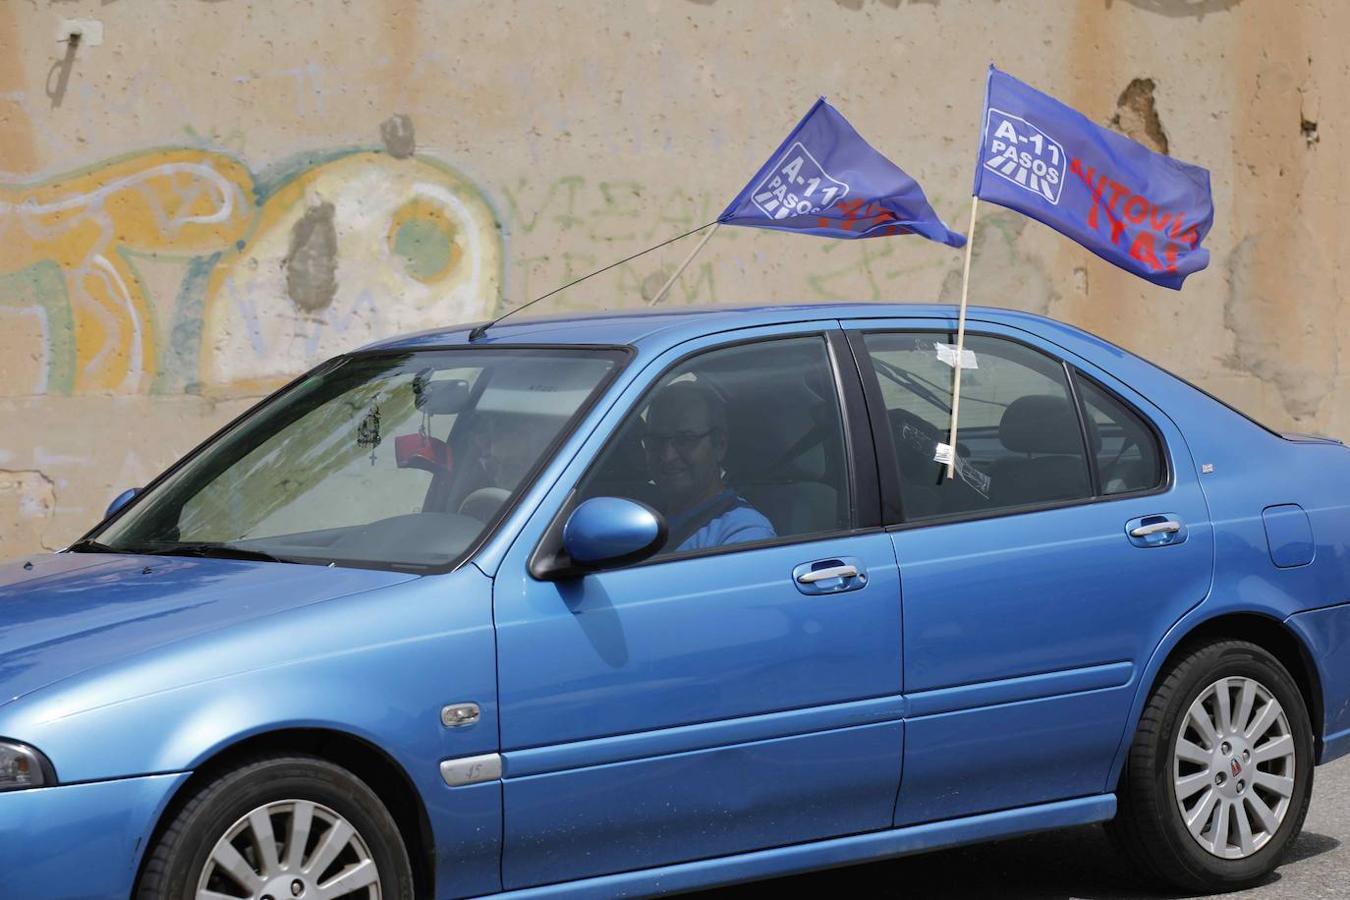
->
643;381;775;552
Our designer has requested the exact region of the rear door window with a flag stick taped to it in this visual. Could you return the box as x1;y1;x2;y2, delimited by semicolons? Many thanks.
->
864;332;1092;519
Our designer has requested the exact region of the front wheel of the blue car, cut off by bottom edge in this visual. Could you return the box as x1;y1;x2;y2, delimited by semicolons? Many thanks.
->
136;756;413;900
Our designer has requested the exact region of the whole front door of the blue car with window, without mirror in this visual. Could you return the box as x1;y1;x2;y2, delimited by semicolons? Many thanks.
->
495;324;903;889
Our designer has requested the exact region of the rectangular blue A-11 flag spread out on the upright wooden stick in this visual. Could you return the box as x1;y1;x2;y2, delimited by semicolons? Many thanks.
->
975;66;1214;290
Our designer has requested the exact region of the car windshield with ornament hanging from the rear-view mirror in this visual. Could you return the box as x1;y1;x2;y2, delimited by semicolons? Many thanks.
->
92;348;624;568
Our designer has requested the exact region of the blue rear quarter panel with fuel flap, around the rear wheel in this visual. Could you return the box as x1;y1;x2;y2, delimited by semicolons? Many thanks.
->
966;312;1350;784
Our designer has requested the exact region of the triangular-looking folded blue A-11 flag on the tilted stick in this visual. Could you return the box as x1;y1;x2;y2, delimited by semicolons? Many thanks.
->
717;97;965;247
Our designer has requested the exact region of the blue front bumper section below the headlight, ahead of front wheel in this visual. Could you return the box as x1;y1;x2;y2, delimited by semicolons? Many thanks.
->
0;772;189;900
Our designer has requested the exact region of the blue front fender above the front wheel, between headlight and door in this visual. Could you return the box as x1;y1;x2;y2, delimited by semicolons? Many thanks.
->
0;563;501;896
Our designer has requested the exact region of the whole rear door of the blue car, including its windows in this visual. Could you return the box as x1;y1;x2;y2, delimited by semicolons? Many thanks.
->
846;320;1214;824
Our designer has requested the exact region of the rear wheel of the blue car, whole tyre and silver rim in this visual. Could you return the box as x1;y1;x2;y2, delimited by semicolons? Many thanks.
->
1111;641;1314;892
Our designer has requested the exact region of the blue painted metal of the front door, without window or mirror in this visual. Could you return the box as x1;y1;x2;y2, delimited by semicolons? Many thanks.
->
495;320;903;888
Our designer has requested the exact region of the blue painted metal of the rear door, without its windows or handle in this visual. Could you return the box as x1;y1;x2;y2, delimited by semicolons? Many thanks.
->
844;318;1214;824
